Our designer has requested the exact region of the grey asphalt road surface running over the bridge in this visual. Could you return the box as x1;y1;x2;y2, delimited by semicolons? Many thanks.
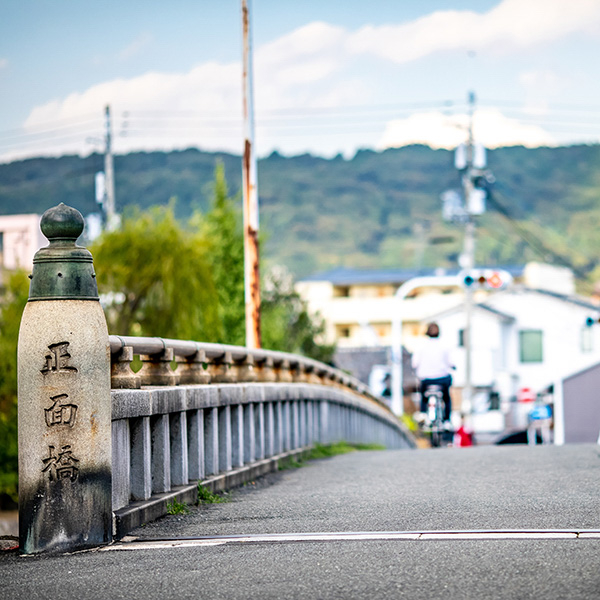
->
0;446;600;600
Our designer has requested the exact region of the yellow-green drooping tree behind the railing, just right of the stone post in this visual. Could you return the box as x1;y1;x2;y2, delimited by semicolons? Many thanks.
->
90;202;220;341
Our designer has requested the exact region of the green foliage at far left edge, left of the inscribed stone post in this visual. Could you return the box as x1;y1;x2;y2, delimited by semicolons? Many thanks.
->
0;271;29;505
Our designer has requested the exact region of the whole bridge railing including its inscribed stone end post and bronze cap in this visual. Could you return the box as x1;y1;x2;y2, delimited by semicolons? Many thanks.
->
18;204;412;553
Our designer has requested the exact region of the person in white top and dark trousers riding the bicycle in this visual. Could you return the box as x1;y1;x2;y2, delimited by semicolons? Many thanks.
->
412;323;455;429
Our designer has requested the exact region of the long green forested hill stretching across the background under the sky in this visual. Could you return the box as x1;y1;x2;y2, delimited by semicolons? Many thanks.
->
0;145;600;281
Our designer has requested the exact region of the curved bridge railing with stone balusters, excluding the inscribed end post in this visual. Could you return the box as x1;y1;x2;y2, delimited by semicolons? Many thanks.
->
109;336;413;536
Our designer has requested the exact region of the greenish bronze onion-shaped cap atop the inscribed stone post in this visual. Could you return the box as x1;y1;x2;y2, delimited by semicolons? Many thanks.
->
29;202;98;302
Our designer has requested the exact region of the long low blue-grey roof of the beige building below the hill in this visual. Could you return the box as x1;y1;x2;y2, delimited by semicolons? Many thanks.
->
301;265;525;285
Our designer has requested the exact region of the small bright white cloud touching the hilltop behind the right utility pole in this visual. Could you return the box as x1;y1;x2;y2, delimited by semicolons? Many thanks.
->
378;109;556;149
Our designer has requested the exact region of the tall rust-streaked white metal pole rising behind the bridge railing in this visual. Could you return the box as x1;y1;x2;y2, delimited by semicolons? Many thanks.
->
242;0;261;348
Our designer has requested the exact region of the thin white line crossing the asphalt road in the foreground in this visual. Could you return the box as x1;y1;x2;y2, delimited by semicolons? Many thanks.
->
99;529;600;552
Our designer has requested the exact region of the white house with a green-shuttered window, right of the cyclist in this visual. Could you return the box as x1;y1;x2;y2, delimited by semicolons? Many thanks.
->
434;286;600;434
